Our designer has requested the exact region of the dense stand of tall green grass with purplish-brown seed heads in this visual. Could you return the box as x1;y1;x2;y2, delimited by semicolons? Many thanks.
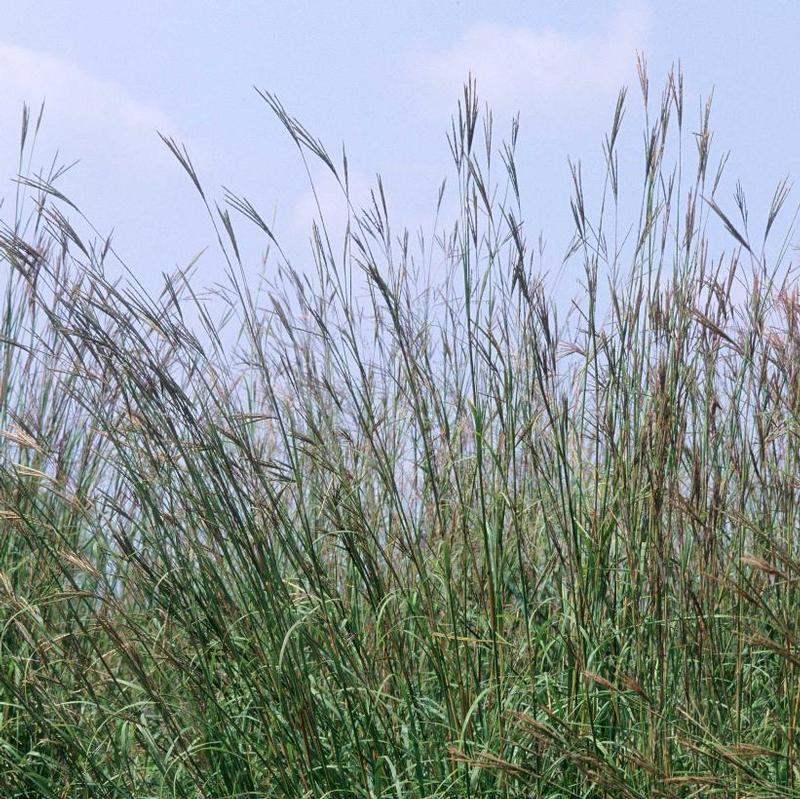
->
0;64;800;799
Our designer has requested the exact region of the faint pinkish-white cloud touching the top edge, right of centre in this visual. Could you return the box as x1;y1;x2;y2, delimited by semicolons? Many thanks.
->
412;0;648;113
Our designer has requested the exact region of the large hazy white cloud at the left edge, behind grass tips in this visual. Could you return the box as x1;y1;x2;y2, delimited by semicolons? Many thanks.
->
0;42;198;284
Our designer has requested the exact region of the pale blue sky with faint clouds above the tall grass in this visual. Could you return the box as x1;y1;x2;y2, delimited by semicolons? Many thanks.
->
0;0;800;292
